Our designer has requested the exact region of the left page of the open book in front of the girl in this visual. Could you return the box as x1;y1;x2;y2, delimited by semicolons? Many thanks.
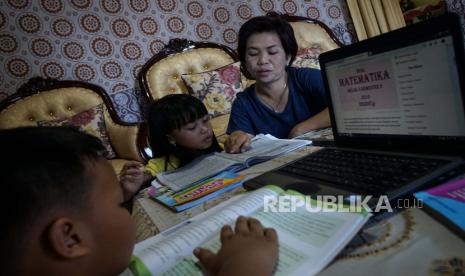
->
157;154;241;192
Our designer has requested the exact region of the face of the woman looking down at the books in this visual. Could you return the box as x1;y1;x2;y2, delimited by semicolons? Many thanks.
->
245;32;290;84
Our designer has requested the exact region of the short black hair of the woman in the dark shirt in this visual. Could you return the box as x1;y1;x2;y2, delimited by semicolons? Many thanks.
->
237;16;298;76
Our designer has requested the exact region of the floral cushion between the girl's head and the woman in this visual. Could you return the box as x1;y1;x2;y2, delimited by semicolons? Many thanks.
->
181;62;242;117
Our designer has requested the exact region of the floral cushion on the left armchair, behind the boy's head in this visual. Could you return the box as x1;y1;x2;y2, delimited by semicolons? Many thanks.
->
37;104;116;159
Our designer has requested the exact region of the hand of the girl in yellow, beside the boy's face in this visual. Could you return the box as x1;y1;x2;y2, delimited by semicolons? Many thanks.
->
119;161;147;200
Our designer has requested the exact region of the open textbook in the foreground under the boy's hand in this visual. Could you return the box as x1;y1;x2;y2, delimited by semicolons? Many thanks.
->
130;186;371;276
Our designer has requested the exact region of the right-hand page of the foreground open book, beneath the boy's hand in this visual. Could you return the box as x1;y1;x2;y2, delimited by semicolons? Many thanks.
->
157;191;369;275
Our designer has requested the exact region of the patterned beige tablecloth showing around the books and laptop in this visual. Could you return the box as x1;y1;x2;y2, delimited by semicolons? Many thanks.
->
129;132;465;275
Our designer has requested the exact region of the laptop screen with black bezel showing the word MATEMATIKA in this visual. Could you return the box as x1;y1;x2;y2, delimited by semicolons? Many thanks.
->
320;13;465;153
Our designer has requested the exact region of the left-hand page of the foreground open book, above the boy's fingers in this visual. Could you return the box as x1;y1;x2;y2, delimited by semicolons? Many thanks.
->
134;188;277;275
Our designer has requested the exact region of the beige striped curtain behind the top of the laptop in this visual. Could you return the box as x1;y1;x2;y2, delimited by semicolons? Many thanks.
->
346;0;405;41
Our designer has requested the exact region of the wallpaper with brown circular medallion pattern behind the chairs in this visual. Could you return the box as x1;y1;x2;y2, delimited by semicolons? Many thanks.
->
0;0;355;121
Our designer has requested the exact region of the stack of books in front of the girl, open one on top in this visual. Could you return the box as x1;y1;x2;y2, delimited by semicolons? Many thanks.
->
149;134;311;212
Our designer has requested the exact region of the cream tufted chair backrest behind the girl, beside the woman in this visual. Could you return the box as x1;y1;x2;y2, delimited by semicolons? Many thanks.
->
139;39;239;140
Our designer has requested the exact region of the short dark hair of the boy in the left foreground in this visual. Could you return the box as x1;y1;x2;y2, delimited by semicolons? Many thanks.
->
0;127;105;272
